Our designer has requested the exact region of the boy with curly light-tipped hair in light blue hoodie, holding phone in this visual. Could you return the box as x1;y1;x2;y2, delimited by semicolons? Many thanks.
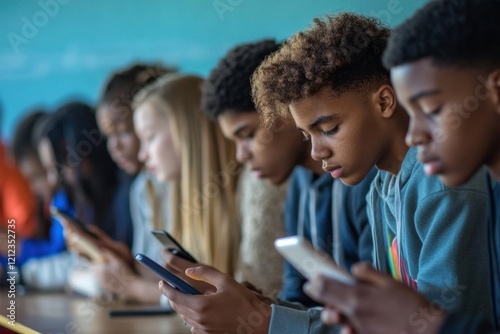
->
161;14;492;333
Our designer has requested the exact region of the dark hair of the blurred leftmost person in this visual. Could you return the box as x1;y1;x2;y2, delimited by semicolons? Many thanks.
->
10;110;47;163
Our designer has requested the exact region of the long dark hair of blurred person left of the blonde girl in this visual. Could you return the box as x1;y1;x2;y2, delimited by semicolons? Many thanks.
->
38;102;118;228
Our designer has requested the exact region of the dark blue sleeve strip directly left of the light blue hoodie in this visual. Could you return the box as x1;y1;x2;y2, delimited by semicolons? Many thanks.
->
340;168;377;268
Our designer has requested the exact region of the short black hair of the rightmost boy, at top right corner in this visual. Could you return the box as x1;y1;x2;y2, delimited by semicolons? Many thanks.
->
383;0;500;69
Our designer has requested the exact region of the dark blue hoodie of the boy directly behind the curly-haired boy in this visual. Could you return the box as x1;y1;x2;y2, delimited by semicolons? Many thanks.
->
279;166;375;306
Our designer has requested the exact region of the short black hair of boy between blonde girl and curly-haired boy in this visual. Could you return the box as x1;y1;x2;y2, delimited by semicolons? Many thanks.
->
202;39;280;119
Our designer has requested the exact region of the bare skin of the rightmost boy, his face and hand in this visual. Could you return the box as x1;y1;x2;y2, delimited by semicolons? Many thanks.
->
304;58;500;334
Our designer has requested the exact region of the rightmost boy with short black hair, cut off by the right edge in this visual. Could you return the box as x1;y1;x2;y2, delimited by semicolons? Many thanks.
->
300;0;500;334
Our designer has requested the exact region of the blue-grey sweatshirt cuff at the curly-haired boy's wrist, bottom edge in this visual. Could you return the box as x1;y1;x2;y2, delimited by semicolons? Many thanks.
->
268;304;340;334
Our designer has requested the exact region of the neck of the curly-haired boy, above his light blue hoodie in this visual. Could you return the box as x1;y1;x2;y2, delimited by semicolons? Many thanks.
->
376;110;409;175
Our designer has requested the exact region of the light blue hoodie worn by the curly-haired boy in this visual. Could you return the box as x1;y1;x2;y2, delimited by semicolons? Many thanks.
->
367;148;493;324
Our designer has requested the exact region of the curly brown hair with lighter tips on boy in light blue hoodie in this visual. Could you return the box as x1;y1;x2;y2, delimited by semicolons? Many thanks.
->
252;13;390;126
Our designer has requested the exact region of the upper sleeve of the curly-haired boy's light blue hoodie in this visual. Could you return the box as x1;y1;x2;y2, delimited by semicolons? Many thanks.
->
410;174;493;321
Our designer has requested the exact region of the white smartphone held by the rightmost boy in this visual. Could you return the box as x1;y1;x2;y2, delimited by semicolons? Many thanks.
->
274;236;356;285
